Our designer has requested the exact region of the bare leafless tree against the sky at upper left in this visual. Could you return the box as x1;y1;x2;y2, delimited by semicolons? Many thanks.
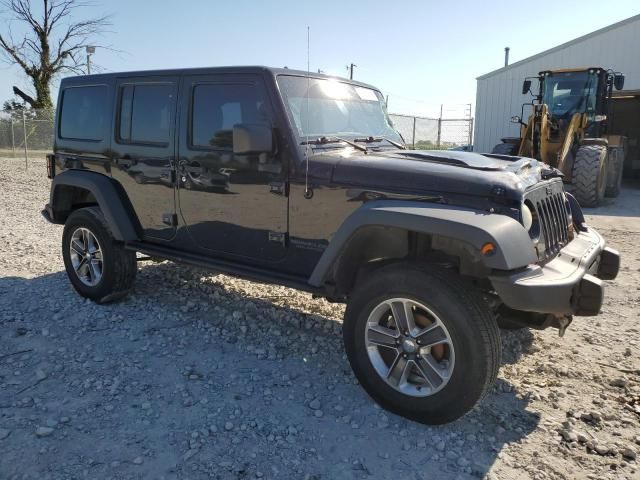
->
0;0;109;109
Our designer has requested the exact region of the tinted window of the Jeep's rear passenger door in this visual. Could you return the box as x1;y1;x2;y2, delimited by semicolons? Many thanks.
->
118;84;173;146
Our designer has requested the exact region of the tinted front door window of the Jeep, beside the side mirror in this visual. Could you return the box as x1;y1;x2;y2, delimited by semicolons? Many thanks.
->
190;84;271;150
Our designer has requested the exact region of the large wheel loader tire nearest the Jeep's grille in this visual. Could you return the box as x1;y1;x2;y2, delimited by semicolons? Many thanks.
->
572;145;607;207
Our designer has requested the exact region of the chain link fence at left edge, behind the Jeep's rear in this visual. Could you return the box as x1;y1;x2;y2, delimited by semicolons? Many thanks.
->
0;110;53;165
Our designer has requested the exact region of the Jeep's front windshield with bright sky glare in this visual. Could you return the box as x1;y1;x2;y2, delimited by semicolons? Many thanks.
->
278;75;404;143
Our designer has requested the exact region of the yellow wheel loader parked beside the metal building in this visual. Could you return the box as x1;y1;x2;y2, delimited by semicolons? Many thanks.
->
492;67;626;207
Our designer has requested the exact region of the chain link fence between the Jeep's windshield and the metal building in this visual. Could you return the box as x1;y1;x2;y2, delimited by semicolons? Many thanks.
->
389;114;473;150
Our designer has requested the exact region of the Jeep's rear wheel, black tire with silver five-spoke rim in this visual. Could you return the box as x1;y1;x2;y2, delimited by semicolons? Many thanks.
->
62;207;137;303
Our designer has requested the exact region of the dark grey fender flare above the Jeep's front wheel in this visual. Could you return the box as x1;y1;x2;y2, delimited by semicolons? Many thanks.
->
309;200;538;287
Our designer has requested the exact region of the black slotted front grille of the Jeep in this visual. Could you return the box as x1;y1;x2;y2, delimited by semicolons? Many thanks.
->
525;179;571;260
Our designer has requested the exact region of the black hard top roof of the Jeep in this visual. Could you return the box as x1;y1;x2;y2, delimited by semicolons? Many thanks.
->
62;66;378;90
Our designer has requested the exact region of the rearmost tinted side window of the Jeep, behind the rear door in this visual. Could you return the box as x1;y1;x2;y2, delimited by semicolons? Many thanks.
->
58;85;108;142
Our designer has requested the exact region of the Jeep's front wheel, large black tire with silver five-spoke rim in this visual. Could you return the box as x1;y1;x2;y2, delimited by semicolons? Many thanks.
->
343;263;501;424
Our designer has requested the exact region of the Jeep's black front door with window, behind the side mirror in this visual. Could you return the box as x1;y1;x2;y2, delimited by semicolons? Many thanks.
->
177;74;288;263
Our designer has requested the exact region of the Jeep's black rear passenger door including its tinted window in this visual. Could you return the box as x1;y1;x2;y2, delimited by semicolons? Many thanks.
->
111;76;178;241
